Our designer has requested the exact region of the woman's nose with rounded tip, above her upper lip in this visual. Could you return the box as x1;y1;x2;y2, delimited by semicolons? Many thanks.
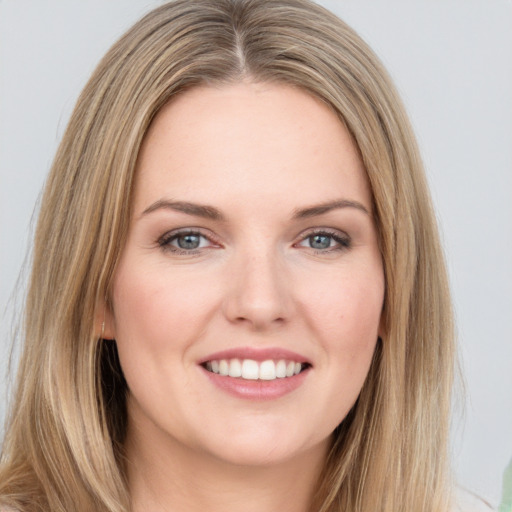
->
224;245;293;331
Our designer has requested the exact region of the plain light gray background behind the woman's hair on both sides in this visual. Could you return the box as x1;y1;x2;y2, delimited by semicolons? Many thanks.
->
0;0;512;505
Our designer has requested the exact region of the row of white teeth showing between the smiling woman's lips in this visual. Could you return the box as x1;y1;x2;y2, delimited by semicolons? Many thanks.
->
201;359;311;381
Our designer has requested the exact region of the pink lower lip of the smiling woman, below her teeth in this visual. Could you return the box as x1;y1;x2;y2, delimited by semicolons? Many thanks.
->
202;368;310;401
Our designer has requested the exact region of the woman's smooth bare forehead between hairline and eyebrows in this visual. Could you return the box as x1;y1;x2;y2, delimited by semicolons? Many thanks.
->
134;82;371;216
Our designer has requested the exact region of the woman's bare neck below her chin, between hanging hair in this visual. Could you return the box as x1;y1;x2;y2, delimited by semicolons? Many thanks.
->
126;418;327;512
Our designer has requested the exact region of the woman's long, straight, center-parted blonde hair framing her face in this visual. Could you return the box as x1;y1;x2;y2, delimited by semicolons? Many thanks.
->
0;0;454;512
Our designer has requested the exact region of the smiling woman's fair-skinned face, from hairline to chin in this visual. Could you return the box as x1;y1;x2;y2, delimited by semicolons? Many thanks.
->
107;83;384;465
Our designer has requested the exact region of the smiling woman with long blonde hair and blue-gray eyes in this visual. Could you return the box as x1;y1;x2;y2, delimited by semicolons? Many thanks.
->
0;0;464;512
